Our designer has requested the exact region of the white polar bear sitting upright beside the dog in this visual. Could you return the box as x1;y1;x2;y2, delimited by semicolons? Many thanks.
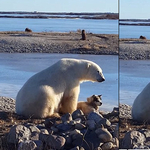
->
16;58;105;118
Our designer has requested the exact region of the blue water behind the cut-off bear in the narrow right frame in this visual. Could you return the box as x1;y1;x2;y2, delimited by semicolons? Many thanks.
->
119;60;150;105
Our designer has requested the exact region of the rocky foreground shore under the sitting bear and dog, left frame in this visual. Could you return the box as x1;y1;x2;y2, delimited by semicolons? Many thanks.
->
0;97;119;150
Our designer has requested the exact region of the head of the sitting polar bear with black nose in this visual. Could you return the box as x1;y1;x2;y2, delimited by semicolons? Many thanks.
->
86;61;105;82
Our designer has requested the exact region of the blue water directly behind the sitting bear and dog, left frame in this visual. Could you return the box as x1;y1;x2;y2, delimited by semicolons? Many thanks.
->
0;53;118;111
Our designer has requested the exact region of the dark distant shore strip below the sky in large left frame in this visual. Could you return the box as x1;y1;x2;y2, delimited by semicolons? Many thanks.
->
0;11;119;20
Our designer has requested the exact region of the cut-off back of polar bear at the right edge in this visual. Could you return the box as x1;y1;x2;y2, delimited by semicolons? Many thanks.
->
132;83;150;122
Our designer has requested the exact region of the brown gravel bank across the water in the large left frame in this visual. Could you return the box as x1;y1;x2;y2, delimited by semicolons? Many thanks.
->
0;30;118;55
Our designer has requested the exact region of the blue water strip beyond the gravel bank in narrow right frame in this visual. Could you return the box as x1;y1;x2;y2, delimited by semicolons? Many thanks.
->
119;25;150;39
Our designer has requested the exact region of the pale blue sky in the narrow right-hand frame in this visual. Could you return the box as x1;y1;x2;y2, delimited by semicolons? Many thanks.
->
120;0;150;19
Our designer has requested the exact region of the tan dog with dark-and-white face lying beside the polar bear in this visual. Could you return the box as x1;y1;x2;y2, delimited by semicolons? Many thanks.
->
77;95;102;115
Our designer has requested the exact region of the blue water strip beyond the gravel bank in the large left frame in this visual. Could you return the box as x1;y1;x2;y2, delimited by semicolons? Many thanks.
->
0;18;118;34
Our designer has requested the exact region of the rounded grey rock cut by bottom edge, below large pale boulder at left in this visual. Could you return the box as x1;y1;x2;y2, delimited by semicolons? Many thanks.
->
18;140;37;150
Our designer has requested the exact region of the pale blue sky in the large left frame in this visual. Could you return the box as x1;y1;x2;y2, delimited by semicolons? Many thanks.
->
0;0;118;13
